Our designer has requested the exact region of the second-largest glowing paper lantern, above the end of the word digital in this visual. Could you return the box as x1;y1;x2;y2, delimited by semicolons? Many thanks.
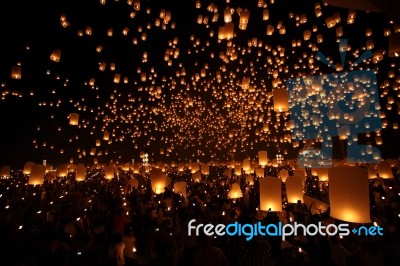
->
260;177;282;212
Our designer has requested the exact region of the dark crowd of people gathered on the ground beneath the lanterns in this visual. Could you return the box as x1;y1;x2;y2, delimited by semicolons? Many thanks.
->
0;162;400;266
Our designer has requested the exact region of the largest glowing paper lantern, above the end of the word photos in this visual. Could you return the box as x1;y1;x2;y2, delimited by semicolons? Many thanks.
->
328;166;371;223
